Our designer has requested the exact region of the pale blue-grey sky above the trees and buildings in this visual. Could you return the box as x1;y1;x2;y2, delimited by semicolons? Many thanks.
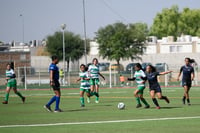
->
0;0;200;43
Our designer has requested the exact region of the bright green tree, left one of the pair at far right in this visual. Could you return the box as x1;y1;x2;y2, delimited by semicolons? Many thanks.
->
150;6;180;38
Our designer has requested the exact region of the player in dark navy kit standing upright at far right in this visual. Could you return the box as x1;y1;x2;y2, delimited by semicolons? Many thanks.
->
177;58;195;105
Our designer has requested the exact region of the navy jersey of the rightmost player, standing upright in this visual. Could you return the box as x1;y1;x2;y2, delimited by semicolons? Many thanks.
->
180;65;194;81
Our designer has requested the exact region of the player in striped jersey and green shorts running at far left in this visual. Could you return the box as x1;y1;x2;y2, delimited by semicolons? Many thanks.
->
2;64;26;104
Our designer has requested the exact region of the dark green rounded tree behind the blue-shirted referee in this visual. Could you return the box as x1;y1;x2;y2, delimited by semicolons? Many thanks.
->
46;32;89;71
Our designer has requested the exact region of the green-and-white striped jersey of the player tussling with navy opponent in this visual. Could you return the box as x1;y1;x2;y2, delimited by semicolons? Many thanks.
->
134;70;146;86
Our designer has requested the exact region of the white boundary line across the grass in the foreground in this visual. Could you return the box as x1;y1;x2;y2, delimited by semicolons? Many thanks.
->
0;116;200;128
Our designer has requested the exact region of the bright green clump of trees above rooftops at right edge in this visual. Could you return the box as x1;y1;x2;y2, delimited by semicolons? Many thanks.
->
150;5;200;38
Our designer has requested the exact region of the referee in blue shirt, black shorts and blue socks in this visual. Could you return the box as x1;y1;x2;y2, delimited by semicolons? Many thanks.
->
44;55;62;112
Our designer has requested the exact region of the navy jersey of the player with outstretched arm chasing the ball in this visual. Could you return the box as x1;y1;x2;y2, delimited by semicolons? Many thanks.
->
146;72;160;89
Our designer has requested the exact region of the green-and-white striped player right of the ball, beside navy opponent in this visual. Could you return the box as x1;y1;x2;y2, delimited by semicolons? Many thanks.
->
128;63;150;108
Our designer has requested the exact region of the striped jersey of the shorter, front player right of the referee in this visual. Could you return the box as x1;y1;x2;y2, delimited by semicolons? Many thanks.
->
79;72;90;89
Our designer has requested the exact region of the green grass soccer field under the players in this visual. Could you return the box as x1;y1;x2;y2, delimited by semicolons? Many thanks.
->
0;87;200;133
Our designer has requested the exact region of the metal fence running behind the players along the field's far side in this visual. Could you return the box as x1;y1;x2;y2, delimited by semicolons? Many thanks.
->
0;65;200;89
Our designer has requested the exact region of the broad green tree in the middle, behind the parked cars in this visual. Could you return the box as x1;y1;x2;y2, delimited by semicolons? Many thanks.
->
96;23;148;69
